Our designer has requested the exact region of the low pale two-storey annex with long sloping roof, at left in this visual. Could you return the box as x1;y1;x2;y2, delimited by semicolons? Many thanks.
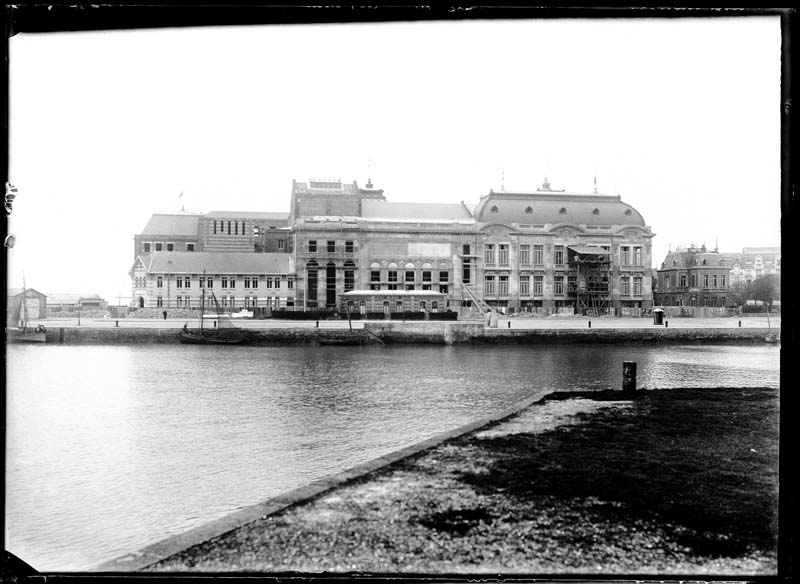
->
129;252;296;310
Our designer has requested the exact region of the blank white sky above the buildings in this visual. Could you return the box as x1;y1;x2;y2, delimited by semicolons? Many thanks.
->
9;16;781;302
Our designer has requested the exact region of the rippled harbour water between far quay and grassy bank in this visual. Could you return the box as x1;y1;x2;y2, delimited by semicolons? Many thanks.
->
6;345;780;571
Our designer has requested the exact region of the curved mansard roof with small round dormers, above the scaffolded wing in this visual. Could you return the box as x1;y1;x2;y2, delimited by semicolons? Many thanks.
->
475;190;646;227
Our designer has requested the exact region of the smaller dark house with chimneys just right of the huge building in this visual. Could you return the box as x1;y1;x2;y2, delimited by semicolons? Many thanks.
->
655;245;735;307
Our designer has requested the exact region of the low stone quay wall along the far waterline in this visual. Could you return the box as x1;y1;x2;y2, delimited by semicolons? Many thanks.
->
47;322;780;345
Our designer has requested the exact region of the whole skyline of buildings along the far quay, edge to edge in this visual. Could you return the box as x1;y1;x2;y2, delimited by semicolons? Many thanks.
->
7;178;781;319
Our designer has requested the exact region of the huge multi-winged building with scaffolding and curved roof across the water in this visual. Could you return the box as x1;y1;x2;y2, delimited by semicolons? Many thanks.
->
131;179;653;314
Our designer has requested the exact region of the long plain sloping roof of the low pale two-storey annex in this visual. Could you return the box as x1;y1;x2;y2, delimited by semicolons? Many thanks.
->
139;251;294;274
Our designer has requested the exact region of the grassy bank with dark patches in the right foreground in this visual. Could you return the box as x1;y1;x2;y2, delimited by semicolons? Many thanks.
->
151;388;778;575
